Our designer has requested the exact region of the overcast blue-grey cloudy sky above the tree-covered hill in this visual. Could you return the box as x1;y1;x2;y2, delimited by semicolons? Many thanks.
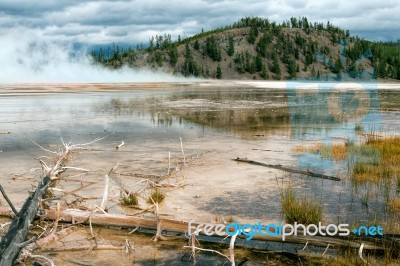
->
0;0;400;82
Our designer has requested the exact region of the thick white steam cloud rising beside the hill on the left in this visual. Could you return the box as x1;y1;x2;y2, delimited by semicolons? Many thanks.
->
0;29;184;83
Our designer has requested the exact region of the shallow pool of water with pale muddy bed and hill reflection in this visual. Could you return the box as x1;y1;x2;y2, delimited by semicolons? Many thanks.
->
0;85;400;231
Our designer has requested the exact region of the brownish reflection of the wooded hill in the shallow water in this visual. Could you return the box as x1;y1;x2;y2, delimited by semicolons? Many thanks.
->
96;88;388;139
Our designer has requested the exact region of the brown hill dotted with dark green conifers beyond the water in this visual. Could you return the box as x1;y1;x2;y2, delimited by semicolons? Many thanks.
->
91;17;400;80
